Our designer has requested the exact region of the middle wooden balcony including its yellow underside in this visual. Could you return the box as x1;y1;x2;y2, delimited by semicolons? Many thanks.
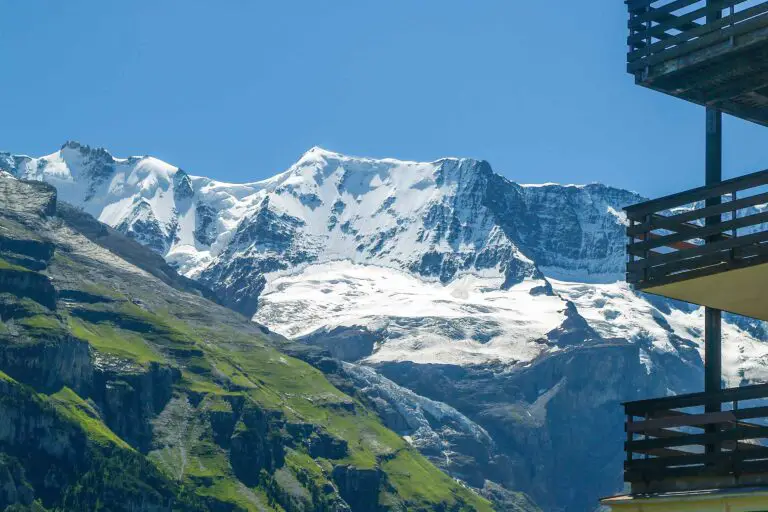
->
625;170;768;320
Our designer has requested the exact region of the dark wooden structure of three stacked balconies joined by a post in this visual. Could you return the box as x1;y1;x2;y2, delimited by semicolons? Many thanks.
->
625;0;768;498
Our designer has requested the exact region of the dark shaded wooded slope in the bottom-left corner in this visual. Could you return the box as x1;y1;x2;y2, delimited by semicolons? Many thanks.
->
0;374;191;512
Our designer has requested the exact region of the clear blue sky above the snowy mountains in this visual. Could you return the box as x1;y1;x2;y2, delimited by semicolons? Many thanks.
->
0;0;768;196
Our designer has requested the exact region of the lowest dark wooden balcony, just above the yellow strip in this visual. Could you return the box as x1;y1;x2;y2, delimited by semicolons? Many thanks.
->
624;384;768;492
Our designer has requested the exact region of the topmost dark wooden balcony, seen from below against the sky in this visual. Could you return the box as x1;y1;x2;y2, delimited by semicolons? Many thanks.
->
626;0;768;125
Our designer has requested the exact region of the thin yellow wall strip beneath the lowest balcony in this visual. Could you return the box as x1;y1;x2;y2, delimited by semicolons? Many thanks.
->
603;491;768;512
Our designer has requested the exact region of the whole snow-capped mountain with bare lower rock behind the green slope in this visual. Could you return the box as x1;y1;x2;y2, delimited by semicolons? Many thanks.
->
6;142;768;511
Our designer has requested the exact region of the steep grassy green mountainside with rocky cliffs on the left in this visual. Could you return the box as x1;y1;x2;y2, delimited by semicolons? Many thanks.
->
0;177;491;511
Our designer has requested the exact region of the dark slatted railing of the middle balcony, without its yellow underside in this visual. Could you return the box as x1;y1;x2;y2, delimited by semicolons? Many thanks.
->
625;170;768;292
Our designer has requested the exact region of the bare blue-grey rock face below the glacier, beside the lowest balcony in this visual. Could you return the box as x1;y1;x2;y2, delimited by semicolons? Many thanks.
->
376;344;652;510
